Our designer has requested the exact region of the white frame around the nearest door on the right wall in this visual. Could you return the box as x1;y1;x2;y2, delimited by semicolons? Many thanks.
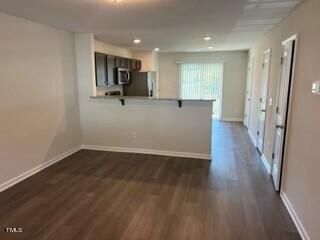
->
271;33;298;192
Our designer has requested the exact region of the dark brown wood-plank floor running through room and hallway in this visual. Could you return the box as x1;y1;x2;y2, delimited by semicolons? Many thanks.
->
0;123;300;240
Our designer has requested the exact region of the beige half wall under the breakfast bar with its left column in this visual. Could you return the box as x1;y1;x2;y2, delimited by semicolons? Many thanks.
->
76;34;212;157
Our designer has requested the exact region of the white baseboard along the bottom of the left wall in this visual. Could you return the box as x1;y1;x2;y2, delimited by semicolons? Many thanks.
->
0;146;81;192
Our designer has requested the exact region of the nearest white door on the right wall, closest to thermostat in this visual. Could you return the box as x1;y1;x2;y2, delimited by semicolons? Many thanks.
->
272;40;295;191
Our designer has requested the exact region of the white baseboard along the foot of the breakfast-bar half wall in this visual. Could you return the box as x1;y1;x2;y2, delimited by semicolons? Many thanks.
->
81;145;211;160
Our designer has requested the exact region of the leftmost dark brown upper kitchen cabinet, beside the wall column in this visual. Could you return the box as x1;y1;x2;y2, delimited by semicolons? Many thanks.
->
94;52;108;87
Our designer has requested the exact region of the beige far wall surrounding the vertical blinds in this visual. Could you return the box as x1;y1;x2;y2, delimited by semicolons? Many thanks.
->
159;51;248;120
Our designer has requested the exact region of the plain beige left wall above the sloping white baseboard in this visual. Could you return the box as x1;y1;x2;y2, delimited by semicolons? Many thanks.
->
0;13;81;188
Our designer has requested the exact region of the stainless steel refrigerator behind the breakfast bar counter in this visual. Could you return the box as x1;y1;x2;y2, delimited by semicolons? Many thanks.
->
123;72;157;97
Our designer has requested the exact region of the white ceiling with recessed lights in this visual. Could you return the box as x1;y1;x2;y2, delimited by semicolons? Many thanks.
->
0;0;301;52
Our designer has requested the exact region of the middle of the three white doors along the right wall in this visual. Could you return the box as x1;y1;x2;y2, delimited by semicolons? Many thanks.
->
257;49;271;154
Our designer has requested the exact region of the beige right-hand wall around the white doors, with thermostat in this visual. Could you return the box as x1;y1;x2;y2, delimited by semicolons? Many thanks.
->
249;0;320;239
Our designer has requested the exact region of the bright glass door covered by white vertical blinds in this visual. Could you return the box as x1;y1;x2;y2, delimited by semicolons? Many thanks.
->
180;63;223;119
